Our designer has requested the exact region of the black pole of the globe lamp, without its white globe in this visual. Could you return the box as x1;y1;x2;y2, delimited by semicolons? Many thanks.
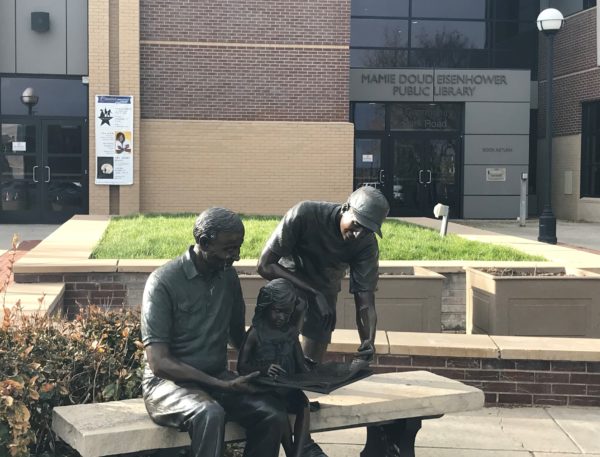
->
538;31;556;244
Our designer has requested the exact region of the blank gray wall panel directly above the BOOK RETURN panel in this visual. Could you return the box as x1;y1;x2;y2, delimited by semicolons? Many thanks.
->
465;102;529;135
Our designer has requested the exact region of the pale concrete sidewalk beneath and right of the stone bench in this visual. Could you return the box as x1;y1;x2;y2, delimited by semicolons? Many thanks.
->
304;407;600;457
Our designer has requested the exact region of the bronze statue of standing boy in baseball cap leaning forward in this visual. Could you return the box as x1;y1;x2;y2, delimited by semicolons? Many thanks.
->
258;187;389;362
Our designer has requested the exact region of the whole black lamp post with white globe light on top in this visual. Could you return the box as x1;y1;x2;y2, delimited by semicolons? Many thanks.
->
537;8;564;244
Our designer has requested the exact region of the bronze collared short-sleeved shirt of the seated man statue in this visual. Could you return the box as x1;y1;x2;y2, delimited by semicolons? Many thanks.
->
142;247;245;376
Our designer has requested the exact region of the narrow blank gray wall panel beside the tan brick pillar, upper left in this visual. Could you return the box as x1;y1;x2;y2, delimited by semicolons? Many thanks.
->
67;0;88;75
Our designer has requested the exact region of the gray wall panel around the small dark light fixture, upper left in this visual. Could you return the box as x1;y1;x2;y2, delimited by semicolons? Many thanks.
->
16;0;67;74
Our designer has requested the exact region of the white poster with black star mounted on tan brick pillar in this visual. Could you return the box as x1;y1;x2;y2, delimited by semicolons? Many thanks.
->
96;95;133;186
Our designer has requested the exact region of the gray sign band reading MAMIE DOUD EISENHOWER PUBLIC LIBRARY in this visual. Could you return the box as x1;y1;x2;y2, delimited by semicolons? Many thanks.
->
350;68;531;102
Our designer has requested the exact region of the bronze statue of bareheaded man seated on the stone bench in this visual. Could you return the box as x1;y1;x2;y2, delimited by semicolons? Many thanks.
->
142;208;289;457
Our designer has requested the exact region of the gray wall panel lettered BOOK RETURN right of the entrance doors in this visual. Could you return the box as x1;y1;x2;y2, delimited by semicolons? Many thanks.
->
464;135;529;165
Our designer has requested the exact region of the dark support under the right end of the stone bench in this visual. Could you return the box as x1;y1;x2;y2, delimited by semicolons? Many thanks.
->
360;418;421;457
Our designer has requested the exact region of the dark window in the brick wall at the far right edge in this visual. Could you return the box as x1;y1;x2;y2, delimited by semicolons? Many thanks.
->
581;102;600;198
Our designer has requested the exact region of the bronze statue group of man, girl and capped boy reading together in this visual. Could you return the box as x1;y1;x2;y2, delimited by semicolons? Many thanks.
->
142;187;389;457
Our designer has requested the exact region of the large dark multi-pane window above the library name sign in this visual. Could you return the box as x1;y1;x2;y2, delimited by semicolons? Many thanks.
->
350;0;540;75
